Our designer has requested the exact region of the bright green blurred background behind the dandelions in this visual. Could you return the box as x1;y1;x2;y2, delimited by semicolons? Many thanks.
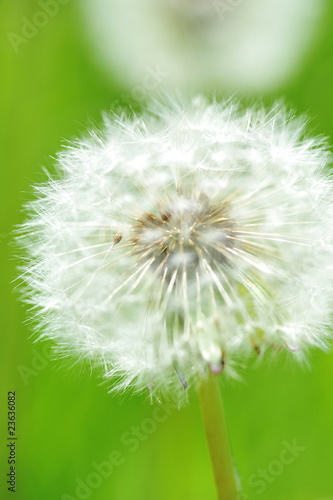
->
0;0;333;500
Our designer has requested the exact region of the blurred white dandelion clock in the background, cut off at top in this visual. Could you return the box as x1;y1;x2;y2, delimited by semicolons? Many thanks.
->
82;0;326;94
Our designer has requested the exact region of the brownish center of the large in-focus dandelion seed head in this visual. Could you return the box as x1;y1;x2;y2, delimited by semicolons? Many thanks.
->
131;195;235;274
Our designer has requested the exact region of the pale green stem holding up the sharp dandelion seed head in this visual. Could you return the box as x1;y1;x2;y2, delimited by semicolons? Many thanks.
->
198;374;240;500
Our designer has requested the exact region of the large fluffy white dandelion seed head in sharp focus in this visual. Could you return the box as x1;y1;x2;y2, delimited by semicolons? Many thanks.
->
17;99;333;406
